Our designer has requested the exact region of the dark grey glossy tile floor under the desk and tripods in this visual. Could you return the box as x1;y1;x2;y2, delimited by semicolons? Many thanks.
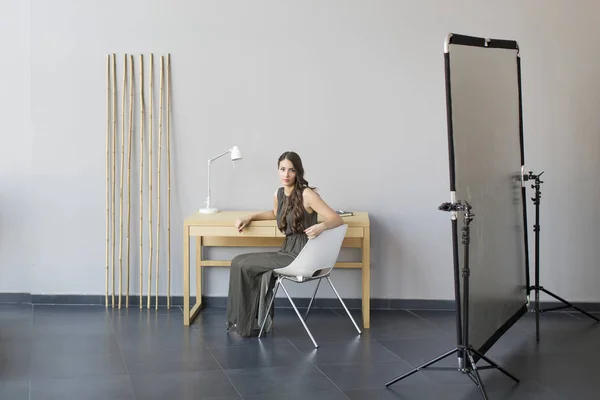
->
0;305;600;400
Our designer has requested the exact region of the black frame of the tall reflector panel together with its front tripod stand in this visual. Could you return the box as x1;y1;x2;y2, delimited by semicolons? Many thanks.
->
386;34;530;399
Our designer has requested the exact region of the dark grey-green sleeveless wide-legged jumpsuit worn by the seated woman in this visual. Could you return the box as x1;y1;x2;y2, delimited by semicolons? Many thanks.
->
227;187;318;337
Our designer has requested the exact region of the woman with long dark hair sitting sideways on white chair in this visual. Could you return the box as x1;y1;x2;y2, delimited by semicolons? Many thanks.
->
227;151;343;337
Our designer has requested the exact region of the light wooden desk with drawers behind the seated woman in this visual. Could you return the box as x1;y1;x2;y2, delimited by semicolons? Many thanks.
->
183;211;371;329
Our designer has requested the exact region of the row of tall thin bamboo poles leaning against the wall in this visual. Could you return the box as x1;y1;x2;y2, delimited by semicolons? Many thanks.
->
105;53;171;309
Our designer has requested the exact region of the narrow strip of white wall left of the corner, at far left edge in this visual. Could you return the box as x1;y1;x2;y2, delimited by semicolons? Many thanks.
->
0;0;30;293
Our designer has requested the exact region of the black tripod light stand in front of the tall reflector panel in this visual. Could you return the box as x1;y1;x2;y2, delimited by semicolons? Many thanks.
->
385;201;519;400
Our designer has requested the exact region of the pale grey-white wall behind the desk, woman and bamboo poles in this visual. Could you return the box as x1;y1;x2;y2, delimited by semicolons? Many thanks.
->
0;0;600;301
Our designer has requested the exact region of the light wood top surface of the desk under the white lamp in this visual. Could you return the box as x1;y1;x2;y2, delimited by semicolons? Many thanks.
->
184;210;370;226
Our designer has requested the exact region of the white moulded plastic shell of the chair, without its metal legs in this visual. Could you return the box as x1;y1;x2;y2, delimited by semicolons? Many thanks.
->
274;224;348;280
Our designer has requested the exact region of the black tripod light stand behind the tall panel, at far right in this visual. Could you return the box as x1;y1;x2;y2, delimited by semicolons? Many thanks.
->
523;171;600;342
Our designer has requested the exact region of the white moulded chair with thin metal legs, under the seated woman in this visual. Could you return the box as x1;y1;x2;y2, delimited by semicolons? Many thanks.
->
258;224;361;347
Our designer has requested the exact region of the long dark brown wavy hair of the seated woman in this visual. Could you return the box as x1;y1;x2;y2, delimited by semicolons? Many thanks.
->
277;151;316;233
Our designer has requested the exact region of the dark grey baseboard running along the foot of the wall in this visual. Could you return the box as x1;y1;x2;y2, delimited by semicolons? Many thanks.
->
0;293;600;312
